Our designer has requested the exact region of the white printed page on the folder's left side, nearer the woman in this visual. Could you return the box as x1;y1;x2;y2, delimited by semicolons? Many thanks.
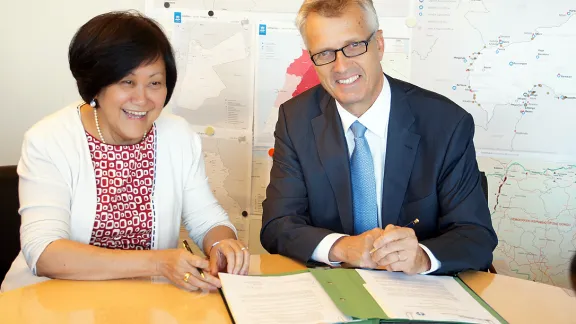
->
219;272;351;324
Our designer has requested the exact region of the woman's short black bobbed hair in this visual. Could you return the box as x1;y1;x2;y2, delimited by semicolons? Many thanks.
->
68;11;177;105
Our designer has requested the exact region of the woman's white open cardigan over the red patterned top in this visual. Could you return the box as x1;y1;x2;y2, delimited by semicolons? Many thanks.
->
1;103;236;291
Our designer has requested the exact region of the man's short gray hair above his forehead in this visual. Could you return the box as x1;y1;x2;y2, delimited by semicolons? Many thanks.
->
296;0;379;36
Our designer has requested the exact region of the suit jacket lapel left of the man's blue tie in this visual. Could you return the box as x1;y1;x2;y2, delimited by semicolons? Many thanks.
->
312;92;354;234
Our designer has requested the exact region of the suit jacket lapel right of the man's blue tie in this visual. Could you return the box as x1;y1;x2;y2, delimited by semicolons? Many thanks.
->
382;78;420;227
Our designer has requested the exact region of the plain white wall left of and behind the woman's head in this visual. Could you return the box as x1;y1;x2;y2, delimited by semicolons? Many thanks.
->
0;0;145;165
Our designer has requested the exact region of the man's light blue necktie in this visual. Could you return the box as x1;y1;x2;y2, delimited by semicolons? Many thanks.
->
350;121;378;235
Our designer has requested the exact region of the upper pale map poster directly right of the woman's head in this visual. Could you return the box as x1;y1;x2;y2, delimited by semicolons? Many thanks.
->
172;12;254;134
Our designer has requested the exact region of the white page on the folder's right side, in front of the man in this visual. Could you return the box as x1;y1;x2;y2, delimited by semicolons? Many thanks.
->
356;270;500;324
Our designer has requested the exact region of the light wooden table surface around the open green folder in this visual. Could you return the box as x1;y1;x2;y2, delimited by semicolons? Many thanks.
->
0;255;576;324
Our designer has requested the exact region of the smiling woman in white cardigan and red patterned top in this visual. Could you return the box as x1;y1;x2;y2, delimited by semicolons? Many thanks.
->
2;12;249;291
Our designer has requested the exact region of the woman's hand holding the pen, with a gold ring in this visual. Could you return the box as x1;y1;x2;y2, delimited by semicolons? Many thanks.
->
156;249;222;291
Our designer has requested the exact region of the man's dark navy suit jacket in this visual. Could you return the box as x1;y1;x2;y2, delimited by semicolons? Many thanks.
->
260;77;497;274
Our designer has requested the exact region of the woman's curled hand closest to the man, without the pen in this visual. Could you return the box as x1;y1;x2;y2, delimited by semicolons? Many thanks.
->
209;239;250;276
